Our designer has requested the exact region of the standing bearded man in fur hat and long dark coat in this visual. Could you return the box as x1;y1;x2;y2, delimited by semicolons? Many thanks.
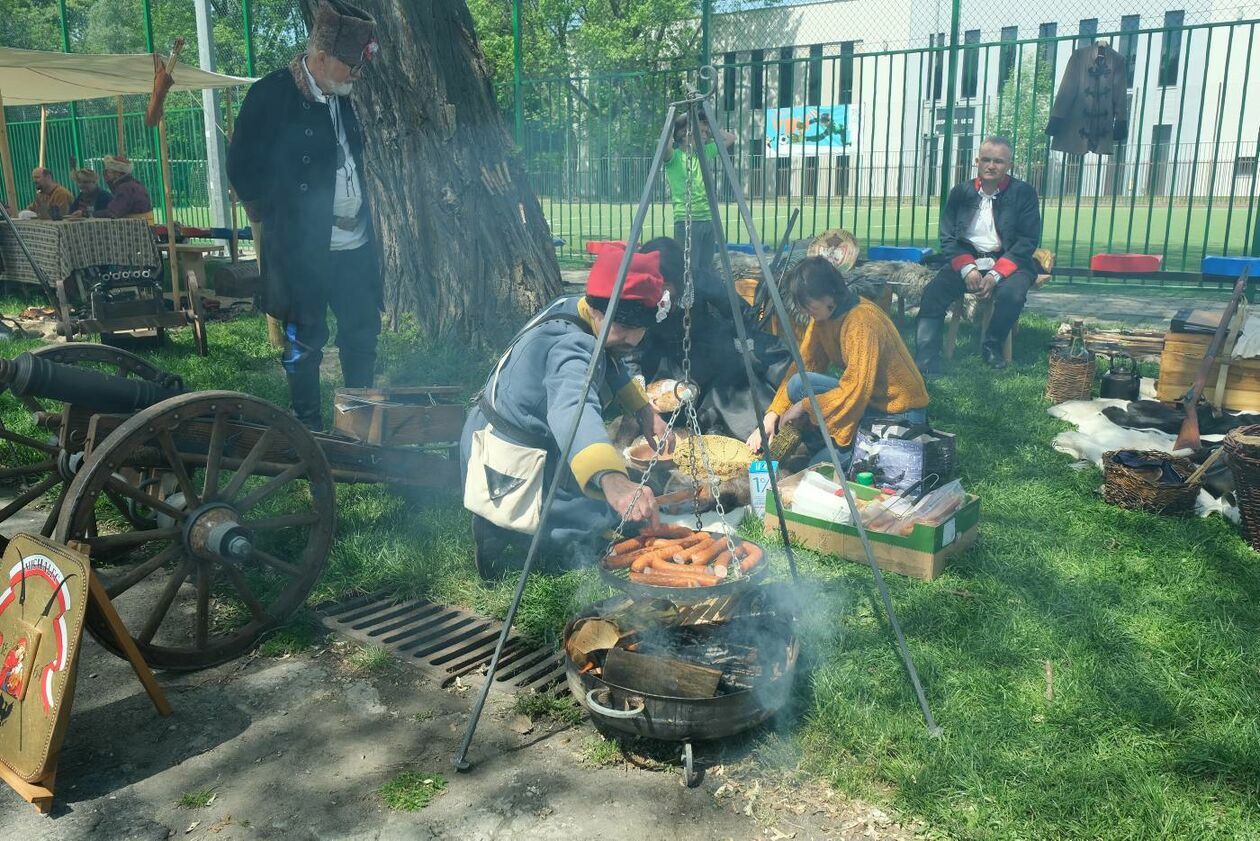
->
228;0;383;430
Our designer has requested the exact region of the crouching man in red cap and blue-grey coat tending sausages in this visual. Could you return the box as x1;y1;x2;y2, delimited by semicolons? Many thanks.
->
460;250;669;579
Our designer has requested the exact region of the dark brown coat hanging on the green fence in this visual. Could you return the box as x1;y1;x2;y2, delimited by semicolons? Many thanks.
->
1046;44;1129;155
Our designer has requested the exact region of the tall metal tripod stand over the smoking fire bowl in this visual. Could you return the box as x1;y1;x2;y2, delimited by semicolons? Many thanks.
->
454;67;941;770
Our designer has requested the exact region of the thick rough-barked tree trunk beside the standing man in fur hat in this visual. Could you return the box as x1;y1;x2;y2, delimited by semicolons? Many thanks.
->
301;0;562;344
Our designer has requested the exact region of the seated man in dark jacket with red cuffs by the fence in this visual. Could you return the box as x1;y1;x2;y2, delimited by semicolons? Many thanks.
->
915;137;1041;374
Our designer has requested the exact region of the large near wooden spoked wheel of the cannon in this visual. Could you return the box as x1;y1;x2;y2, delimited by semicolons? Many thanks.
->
55;391;335;670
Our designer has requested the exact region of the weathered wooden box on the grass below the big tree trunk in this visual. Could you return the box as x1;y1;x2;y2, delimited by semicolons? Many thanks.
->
333;386;464;446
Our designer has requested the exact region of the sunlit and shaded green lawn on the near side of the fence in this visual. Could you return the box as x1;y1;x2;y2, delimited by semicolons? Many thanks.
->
0;292;1260;841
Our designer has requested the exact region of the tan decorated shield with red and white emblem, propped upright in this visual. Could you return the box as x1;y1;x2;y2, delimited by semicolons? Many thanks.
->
0;535;88;782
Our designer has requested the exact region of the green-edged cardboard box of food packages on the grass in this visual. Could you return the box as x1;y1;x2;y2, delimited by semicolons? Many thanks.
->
765;483;980;581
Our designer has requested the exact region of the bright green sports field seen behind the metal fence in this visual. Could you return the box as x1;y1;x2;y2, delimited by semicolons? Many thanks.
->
539;195;1254;271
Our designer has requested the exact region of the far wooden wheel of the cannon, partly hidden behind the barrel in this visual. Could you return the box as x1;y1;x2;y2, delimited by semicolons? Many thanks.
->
0;343;171;537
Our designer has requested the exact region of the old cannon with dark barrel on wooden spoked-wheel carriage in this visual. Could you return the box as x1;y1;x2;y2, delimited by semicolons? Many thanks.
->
0;344;459;670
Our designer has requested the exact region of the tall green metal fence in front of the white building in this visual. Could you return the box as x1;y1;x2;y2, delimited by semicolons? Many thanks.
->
500;20;1260;272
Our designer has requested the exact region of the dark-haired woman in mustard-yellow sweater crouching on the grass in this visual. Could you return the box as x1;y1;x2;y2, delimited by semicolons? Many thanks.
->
748;257;927;469
